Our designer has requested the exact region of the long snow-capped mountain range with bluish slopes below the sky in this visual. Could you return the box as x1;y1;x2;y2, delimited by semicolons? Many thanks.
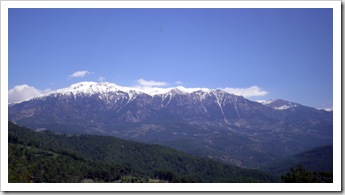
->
9;82;333;167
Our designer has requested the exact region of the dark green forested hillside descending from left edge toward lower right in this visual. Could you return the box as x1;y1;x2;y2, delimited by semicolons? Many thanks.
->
8;123;279;183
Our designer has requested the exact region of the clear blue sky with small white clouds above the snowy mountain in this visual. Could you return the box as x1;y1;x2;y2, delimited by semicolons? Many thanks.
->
8;8;333;108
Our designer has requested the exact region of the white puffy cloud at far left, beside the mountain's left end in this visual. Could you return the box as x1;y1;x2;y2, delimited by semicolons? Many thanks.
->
8;84;52;103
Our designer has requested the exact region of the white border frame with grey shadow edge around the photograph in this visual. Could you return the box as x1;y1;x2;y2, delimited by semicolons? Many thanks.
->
0;0;342;191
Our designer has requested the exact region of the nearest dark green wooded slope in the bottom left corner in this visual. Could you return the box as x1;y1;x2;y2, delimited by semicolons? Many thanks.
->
8;143;130;183
